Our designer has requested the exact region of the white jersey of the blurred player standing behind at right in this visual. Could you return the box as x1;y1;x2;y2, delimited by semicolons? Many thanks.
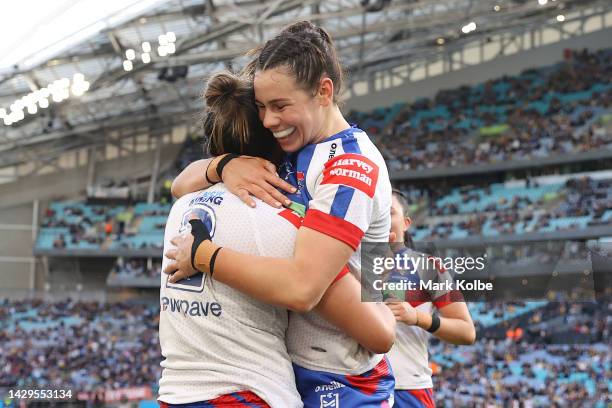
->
387;248;459;390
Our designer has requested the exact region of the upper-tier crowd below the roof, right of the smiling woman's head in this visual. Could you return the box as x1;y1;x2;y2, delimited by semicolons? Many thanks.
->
350;50;612;170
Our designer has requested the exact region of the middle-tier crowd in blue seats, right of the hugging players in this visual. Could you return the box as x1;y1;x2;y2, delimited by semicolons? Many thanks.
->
406;176;612;240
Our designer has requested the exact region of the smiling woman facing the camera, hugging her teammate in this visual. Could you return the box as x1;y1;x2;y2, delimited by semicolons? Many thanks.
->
165;21;394;407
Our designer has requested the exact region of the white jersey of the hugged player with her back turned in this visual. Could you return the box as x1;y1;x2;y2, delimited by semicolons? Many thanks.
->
159;184;303;408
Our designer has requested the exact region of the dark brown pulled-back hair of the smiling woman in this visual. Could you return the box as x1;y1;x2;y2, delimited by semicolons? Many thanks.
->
250;21;344;103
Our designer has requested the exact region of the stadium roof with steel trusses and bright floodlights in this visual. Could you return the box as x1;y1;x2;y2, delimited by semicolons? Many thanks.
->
0;0;610;172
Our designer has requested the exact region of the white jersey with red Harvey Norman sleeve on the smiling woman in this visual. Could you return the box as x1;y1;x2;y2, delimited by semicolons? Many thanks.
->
281;128;391;375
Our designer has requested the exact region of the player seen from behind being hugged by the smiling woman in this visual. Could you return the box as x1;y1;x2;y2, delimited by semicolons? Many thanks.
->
159;73;393;408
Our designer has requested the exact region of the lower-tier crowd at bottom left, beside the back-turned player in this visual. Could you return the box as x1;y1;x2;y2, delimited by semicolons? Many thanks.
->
0;300;161;392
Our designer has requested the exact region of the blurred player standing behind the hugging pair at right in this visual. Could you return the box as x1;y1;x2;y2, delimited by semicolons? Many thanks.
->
387;190;476;408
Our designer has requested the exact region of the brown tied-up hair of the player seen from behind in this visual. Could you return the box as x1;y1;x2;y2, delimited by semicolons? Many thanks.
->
204;71;282;162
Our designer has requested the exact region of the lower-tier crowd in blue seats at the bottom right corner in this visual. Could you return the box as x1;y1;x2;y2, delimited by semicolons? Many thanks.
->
430;301;612;408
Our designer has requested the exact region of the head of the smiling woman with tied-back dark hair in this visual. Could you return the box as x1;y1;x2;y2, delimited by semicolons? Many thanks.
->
253;22;349;152
